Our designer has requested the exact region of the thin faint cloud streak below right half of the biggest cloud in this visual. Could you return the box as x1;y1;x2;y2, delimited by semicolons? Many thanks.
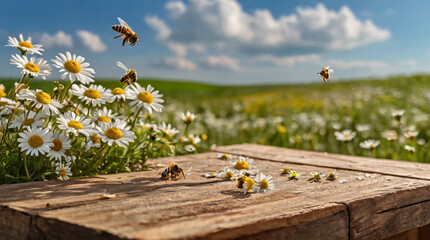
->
251;54;321;67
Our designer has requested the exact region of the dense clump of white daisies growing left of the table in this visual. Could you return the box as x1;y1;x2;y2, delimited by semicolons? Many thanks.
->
0;35;203;182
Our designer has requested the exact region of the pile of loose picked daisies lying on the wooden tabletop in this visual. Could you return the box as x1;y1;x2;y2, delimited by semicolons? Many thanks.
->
202;154;275;194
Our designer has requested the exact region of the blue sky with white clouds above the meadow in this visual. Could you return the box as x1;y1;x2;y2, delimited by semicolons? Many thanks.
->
0;0;430;84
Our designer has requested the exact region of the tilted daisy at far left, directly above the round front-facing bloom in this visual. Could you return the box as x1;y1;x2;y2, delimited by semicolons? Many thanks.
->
16;89;63;115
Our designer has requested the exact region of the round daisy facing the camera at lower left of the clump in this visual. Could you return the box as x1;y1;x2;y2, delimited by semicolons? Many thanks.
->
18;127;54;156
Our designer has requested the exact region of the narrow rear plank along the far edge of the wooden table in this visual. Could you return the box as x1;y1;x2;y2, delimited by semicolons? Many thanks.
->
215;144;430;180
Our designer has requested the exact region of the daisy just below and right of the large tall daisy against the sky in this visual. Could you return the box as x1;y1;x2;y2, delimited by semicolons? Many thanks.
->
72;84;110;107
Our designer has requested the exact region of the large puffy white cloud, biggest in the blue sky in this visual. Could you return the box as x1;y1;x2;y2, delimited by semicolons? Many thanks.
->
150;0;391;54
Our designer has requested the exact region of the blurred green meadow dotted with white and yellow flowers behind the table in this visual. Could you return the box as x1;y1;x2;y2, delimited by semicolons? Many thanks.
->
1;75;430;165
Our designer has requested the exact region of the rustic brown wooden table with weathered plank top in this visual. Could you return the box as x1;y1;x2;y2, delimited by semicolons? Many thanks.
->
0;144;430;239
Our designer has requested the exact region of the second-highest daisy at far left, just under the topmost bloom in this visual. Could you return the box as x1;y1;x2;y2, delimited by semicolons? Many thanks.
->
10;54;51;80
